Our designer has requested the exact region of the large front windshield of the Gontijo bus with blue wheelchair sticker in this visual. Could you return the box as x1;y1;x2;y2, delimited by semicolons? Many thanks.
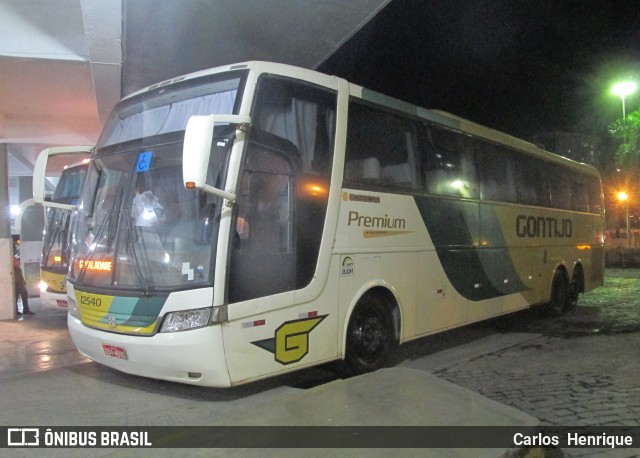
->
69;72;243;293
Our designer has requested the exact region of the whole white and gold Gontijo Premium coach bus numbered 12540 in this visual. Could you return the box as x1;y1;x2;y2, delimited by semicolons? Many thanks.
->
35;62;604;387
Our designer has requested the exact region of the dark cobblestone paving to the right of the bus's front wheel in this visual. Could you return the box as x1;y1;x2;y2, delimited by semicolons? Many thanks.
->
396;269;640;456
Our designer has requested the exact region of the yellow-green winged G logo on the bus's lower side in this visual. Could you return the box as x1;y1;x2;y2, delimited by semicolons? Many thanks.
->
251;315;328;364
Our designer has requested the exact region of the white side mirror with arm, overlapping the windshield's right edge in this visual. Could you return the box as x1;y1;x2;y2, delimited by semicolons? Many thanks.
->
182;115;251;202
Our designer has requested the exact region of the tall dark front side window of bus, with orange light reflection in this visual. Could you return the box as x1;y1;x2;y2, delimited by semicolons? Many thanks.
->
228;76;337;302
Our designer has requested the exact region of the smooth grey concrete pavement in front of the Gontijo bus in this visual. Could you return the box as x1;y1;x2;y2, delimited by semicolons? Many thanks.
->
0;301;539;458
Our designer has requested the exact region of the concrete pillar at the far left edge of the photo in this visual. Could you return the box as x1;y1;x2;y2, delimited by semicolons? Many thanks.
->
0;143;16;320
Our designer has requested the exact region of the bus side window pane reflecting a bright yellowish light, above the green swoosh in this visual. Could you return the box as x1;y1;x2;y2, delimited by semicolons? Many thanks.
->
424;126;478;199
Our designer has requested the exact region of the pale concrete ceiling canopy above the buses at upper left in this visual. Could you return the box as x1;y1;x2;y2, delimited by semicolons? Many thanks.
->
0;0;389;183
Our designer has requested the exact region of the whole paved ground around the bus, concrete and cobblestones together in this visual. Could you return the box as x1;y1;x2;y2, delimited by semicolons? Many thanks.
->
0;271;640;457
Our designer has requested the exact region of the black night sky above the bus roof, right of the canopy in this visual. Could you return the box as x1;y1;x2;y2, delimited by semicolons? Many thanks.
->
319;0;640;140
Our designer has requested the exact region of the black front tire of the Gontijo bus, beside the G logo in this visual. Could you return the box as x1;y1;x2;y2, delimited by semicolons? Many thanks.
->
345;295;397;375
